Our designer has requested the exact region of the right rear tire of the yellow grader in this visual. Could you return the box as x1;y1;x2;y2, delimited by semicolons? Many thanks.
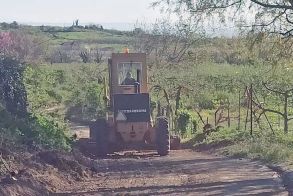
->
156;117;170;156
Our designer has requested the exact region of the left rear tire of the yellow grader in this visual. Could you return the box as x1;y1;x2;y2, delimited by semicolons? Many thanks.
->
90;119;109;156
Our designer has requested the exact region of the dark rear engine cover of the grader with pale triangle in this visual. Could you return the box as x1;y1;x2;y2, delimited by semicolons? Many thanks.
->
114;93;150;122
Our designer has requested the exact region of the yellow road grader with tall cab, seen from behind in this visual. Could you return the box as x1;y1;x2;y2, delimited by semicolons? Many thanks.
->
90;51;170;156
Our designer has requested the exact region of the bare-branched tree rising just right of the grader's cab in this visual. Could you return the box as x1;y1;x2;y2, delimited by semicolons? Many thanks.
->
133;17;205;132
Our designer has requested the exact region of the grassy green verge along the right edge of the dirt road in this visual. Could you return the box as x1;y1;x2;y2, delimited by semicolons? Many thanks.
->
187;128;293;168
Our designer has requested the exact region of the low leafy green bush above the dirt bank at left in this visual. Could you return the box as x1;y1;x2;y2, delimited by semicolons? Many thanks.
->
0;108;70;150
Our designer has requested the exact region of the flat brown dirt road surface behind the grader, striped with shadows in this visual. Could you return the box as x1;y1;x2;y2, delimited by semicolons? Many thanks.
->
50;150;288;195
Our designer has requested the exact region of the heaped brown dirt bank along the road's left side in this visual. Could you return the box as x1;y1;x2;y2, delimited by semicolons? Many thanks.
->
0;145;94;195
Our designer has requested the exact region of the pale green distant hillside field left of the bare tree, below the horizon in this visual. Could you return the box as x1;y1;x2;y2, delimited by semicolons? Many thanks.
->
0;26;134;52
